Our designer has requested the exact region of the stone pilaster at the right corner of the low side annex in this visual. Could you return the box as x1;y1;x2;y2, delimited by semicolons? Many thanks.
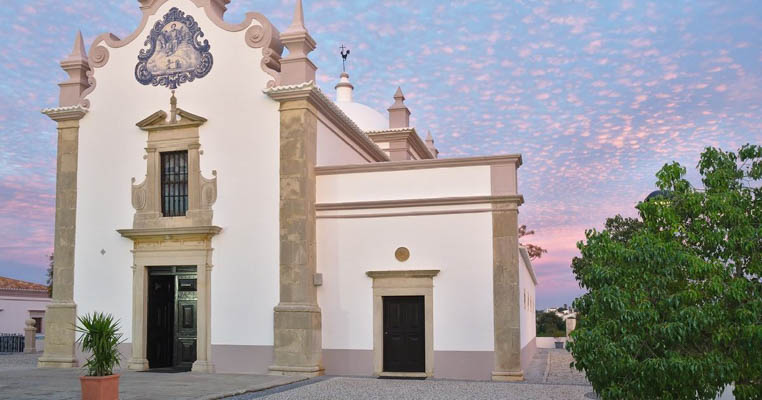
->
492;203;524;381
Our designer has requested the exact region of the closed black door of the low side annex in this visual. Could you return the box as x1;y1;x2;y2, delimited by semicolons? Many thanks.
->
383;296;426;372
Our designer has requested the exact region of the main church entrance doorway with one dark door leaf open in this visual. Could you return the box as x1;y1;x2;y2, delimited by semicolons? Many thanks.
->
146;266;198;371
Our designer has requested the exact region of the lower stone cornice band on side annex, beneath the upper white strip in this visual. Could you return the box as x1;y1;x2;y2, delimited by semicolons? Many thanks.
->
315;194;524;211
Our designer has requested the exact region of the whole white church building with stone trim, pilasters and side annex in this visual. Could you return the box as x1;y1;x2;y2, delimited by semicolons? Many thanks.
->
39;0;537;380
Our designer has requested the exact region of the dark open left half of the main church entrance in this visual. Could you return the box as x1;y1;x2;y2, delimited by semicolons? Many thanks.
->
146;275;175;368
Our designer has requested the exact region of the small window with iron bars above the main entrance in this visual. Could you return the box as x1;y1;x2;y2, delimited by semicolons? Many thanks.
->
161;151;188;217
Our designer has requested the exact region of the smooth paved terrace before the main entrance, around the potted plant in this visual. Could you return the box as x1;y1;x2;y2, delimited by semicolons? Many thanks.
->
0;354;302;400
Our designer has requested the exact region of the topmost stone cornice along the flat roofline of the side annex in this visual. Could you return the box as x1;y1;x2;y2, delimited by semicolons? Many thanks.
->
315;154;522;175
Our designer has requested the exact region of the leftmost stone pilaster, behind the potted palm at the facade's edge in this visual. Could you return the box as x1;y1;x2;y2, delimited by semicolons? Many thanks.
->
37;106;86;368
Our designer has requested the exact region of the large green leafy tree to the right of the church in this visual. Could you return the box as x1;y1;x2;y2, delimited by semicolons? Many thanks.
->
567;145;762;399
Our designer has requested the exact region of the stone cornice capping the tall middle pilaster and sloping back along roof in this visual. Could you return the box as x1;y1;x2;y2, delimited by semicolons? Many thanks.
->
264;81;389;161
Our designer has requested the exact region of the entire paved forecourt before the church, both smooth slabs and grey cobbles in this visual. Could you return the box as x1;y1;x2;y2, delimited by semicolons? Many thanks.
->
0;349;593;400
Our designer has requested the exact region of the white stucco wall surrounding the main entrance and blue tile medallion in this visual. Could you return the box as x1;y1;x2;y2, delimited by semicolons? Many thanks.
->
74;0;279;345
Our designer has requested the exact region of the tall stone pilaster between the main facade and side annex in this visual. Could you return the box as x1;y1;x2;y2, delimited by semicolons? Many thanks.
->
270;98;323;376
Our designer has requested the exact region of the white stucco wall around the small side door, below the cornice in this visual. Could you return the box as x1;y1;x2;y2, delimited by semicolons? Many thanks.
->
317;213;494;351
